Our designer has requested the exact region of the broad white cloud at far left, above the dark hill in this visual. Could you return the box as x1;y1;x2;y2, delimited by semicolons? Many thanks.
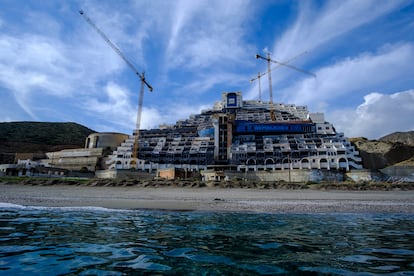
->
0;15;131;124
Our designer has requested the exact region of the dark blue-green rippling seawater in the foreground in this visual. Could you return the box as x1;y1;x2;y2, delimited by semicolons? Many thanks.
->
0;204;414;275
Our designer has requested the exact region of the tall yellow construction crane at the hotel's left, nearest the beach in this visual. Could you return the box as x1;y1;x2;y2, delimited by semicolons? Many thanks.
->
79;10;153;167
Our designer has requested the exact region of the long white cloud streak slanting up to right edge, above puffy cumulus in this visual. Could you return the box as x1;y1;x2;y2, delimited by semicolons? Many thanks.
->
279;44;414;111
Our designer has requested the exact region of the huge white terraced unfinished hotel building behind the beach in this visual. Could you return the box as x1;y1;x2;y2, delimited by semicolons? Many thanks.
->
107;92;362;172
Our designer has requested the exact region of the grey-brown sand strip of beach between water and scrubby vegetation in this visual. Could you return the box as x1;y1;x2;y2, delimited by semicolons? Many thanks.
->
0;184;414;214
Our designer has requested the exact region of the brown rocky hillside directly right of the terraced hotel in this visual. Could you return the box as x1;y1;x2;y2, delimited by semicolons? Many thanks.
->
350;131;414;169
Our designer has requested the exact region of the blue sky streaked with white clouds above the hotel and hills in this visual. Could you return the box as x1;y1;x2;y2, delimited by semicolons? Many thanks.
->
0;0;414;139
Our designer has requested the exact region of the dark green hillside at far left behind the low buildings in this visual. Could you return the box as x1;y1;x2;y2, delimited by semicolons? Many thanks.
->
0;122;95;164
